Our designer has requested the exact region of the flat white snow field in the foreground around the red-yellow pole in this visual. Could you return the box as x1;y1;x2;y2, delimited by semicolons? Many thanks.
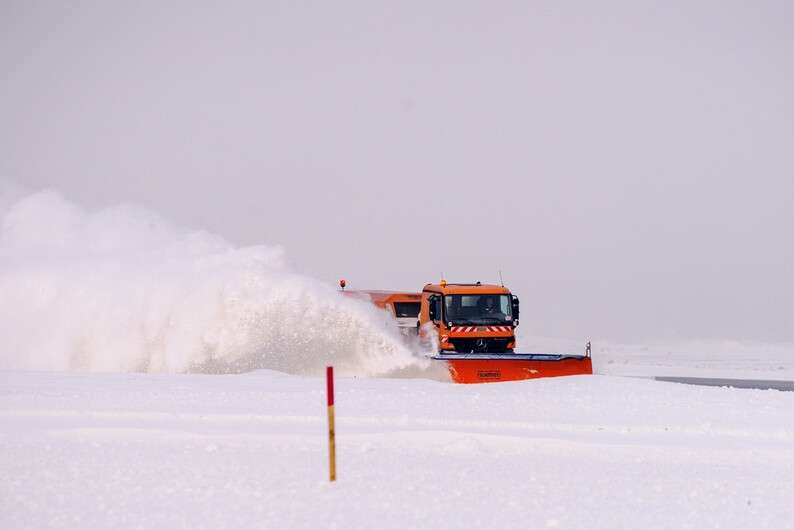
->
0;370;794;529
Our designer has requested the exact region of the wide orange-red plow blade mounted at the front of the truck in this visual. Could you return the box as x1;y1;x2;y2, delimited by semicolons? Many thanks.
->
433;353;593;383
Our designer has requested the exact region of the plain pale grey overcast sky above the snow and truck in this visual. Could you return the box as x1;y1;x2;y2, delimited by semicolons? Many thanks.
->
0;0;794;341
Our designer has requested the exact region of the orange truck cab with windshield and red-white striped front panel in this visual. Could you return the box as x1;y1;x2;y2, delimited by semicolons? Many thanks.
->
417;280;519;353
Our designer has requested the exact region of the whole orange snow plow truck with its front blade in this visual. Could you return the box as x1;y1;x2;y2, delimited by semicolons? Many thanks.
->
340;280;593;383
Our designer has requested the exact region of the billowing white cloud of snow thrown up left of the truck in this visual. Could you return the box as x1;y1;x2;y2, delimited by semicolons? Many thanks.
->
0;191;423;375
